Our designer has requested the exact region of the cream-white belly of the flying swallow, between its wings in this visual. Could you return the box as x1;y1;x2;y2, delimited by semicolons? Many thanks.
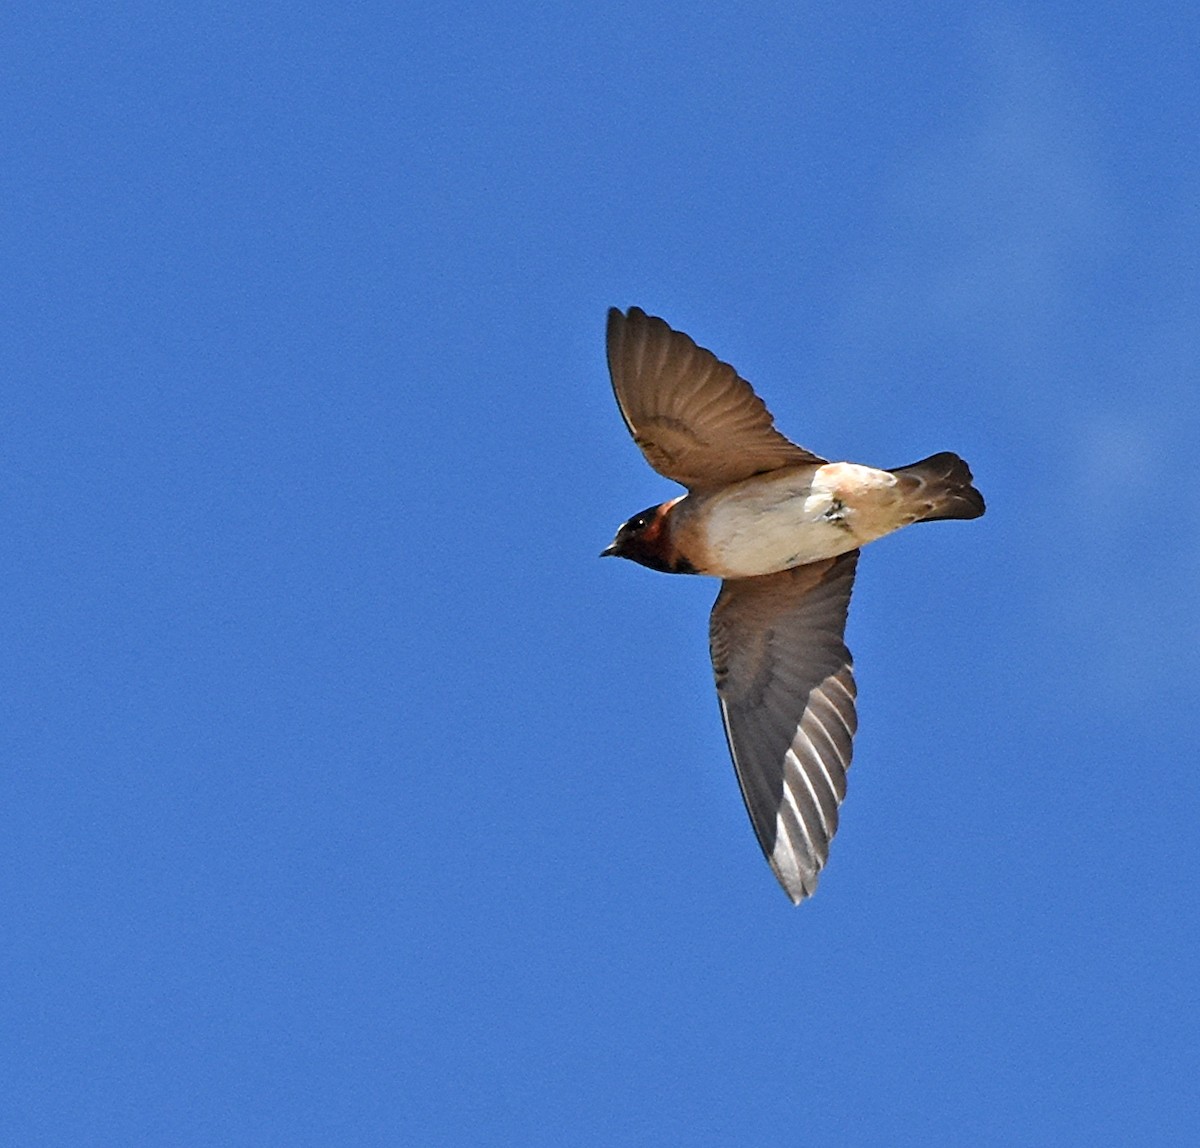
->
702;463;900;578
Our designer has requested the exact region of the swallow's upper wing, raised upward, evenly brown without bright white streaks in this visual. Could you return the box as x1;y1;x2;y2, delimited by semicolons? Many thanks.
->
608;307;824;489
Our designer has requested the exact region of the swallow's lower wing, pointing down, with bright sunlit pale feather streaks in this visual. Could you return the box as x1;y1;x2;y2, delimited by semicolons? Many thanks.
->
709;551;858;903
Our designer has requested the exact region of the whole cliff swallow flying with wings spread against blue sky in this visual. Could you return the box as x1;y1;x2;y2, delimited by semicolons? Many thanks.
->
602;307;984;904
